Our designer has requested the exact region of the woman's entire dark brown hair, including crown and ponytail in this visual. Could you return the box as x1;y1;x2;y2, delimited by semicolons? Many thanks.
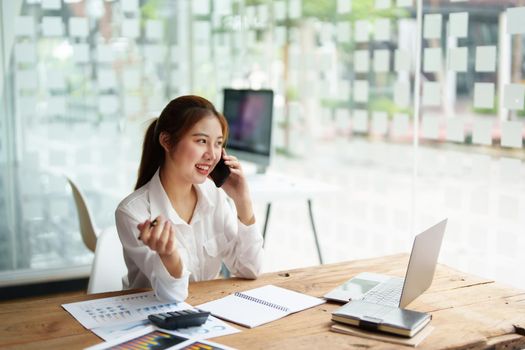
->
135;95;228;189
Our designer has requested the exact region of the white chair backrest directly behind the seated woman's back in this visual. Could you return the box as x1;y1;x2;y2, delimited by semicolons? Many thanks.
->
87;227;128;294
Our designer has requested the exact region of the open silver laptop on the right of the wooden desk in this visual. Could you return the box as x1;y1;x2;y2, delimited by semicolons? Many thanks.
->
324;219;447;308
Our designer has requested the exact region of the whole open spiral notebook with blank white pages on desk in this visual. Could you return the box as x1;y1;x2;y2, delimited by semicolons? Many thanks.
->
197;284;325;328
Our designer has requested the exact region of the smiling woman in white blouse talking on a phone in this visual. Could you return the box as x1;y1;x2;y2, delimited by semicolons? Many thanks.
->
115;96;262;301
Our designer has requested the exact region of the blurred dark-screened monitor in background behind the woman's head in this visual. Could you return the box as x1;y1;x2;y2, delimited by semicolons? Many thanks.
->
223;89;273;172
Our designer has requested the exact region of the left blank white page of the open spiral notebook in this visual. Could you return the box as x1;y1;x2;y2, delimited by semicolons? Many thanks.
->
197;294;289;328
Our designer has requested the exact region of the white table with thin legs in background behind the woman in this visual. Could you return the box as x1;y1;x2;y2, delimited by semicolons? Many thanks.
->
247;172;337;264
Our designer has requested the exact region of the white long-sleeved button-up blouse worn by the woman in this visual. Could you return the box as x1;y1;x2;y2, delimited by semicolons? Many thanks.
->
115;170;263;301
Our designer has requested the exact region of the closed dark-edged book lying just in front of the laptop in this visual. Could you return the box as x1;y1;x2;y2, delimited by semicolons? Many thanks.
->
332;300;432;337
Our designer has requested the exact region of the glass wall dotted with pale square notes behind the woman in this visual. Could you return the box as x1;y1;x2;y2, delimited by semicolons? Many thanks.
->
0;0;525;288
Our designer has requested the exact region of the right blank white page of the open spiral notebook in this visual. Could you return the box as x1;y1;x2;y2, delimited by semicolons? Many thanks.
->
242;284;326;313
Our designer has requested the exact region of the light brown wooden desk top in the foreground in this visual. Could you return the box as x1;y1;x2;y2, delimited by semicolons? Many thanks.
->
0;254;525;349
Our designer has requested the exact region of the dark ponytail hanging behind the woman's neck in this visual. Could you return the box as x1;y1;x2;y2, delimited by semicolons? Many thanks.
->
135;118;164;190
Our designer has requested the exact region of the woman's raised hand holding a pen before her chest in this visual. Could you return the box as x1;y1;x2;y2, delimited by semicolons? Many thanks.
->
137;215;177;257
